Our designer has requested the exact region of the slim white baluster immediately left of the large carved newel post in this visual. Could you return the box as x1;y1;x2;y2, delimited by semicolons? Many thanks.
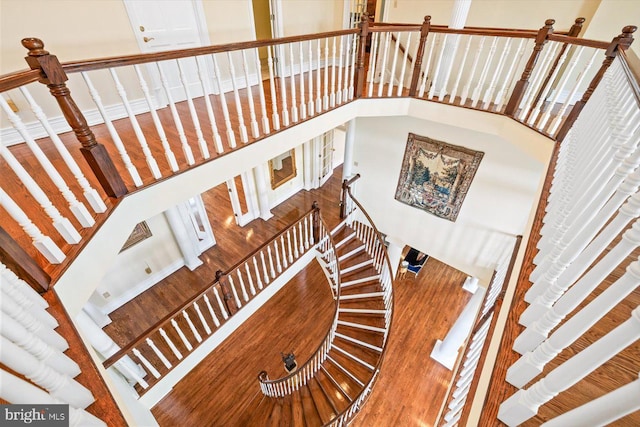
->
20;86;107;213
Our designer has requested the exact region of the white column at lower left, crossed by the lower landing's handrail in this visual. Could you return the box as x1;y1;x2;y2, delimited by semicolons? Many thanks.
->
75;310;145;384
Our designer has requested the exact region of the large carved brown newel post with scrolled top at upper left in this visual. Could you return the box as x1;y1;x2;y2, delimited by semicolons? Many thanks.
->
22;38;127;197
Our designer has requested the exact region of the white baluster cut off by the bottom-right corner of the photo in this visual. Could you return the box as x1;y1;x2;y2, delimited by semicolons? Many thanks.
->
542;379;640;427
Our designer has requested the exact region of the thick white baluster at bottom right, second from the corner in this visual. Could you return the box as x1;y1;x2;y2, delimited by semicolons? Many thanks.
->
498;307;640;426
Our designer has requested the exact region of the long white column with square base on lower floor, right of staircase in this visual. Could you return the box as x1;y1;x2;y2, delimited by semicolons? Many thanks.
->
431;288;486;370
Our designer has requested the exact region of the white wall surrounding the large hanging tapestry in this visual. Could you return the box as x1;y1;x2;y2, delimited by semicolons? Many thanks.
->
354;117;545;283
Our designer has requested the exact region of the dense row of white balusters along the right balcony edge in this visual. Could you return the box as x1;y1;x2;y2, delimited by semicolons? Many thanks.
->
498;57;640;425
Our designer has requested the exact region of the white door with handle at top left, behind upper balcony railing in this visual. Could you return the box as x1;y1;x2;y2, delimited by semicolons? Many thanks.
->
124;0;212;102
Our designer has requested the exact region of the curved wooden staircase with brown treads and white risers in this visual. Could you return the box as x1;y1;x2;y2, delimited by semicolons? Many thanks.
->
242;225;385;427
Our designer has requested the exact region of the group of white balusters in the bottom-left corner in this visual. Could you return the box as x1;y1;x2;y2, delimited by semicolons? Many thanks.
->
0;263;106;426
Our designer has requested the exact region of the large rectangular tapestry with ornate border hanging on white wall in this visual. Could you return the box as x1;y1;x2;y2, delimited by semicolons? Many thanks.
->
395;133;484;221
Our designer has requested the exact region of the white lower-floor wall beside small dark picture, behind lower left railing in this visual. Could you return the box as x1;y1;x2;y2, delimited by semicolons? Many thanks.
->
90;214;184;313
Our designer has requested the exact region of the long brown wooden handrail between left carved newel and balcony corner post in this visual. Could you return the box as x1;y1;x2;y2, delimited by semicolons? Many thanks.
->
62;28;358;73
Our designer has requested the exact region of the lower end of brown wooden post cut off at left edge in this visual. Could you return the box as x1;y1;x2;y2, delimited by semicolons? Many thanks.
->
0;227;51;293
